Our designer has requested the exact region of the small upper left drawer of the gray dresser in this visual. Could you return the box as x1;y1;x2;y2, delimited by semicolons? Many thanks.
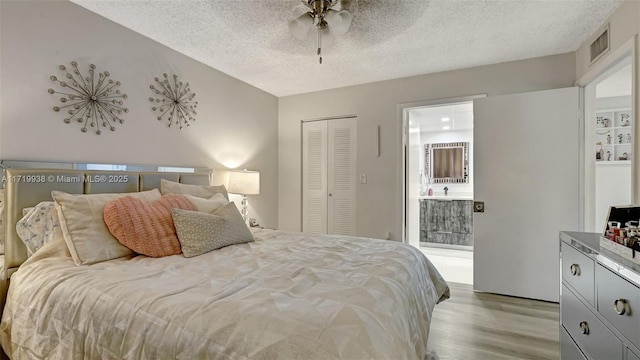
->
561;243;596;306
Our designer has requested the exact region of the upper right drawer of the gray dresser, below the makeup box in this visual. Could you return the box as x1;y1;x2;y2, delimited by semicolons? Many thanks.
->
596;264;640;346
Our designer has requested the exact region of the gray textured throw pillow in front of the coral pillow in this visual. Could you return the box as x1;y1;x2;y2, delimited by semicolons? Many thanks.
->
171;202;253;257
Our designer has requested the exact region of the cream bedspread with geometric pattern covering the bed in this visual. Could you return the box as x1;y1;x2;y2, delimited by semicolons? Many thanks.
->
0;230;448;360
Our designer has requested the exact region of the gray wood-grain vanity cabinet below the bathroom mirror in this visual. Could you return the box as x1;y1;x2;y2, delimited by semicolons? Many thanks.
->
419;196;473;246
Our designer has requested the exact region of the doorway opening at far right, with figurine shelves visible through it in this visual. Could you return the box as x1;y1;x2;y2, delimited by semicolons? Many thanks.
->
579;53;638;233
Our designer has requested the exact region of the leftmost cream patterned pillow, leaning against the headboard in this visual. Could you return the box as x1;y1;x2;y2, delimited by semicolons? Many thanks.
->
16;201;63;256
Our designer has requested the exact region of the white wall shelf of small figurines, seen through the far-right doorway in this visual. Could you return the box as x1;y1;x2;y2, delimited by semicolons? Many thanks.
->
595;108;634;164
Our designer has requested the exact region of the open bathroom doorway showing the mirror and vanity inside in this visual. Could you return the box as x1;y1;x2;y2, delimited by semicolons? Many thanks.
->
401;97;474;284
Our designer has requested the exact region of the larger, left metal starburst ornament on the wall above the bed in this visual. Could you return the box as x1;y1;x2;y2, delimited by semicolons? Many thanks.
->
48;61;129;135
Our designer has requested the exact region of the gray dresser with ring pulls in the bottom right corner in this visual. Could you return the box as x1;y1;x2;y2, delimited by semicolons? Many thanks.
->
560;231;640;360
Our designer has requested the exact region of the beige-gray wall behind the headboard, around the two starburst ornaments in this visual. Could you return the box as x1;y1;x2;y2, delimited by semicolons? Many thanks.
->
0;1;278;227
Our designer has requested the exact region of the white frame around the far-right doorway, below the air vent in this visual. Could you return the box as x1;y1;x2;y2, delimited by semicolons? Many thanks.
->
574;35;640;231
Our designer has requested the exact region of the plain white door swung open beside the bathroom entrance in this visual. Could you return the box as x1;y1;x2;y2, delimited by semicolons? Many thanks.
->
473;88;581;302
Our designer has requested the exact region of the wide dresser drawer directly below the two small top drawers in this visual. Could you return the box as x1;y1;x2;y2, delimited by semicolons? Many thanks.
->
562;285;623;360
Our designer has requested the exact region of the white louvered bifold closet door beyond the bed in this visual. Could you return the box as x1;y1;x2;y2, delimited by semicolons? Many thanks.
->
302;118;357;235
